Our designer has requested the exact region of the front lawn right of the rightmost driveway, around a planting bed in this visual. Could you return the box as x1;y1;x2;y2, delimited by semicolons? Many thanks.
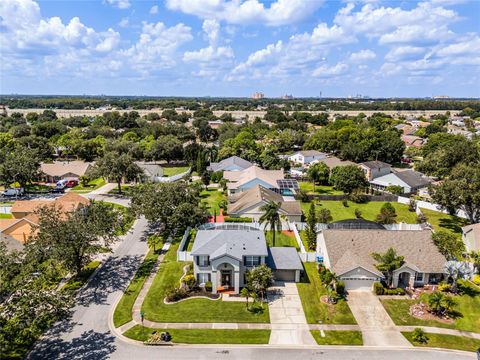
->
381;295;480;332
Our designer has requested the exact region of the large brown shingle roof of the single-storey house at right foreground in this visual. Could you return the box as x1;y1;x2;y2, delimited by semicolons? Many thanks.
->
322;230;447;275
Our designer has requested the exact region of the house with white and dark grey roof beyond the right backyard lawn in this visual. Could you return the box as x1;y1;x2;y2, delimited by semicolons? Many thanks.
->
370;170;432;194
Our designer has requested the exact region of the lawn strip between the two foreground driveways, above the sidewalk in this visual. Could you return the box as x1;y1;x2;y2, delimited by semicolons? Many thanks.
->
297;263;357;324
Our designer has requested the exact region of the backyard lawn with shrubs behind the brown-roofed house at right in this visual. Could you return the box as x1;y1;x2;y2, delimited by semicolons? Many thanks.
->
301;200;417;224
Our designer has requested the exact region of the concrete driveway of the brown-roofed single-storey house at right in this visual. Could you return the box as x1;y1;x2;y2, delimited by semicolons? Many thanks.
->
348;291;412;347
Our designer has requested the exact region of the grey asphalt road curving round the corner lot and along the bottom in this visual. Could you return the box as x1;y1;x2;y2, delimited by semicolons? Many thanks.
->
27;194;475;360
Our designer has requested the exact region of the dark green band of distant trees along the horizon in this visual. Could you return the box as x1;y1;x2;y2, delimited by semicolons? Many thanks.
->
0;95;480;111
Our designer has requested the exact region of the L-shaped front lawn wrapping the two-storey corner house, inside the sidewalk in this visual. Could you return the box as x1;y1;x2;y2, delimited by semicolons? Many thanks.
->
142;243;270;323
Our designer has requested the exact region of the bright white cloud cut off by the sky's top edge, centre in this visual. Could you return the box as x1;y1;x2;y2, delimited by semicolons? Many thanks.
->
166;0;323;26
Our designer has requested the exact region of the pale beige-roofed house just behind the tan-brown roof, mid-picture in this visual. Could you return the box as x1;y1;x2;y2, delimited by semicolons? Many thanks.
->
223;166;284;195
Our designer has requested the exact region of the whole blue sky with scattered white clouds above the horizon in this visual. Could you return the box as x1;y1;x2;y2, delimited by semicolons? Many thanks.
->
0;0;480;97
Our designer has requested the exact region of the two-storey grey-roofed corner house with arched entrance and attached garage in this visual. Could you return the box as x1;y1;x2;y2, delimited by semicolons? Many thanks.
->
190;228;303;294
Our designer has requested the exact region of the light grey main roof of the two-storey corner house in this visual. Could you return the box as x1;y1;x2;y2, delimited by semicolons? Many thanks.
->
191;230;268;261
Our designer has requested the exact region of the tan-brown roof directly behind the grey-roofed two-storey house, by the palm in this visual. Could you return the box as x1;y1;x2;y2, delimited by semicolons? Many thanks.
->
227;185;302;215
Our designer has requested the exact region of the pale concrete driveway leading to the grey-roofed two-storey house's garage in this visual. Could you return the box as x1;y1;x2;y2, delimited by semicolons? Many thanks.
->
268;283;316;345
